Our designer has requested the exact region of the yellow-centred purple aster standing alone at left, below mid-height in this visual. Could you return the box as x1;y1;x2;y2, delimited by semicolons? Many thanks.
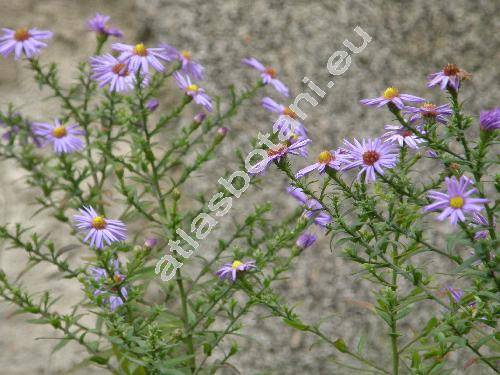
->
73;206;127;249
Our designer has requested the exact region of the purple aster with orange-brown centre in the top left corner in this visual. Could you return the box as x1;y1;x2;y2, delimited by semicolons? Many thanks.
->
0;27;52;60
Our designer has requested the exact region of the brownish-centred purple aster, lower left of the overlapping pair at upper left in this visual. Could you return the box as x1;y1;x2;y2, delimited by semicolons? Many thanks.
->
90;53;140;92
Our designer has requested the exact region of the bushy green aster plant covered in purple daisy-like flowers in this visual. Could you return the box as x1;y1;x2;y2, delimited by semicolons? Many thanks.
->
0;14;500;375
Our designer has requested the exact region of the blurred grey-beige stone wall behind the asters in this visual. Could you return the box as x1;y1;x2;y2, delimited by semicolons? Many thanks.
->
0;0;500;374
